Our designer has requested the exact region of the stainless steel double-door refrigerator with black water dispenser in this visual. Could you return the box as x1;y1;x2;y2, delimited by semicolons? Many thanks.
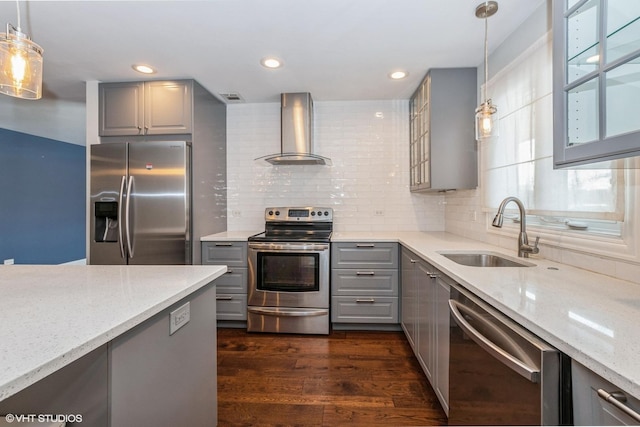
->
89;141;192;265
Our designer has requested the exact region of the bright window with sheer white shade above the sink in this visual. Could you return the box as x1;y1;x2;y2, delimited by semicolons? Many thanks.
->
481;34;625;236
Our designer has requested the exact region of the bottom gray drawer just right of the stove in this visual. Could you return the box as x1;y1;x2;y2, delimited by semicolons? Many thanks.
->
331;296;398;323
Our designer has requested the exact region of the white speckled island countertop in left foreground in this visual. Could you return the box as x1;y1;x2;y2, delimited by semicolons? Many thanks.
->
0;265;227;401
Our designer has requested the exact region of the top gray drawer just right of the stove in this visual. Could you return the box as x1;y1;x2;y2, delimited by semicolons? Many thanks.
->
331;242;398;268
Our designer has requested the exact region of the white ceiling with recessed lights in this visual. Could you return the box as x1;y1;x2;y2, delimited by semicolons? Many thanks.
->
0;0;545;144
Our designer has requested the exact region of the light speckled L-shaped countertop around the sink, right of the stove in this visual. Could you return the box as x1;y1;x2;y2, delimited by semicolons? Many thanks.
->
205;232;640;398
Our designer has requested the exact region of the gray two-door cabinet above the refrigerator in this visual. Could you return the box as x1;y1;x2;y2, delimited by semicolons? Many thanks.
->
99;80;193;136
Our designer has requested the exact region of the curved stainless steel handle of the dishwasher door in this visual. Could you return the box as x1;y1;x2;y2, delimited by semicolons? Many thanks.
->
449;300;540;383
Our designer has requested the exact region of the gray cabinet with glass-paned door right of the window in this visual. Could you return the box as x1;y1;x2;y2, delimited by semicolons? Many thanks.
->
552;0;640;168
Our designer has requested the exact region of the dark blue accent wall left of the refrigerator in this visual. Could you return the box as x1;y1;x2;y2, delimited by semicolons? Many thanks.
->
0;129;86;264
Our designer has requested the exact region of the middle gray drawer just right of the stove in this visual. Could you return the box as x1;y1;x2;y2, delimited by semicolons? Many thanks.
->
331;268;398;297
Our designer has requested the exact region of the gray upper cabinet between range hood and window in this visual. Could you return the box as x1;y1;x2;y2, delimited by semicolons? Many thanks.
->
409;68;478;191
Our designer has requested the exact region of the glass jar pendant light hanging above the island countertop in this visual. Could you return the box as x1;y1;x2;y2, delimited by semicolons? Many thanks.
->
0;0;42;99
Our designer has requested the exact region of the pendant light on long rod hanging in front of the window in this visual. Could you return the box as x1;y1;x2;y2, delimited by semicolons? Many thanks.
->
476;1;498;141
